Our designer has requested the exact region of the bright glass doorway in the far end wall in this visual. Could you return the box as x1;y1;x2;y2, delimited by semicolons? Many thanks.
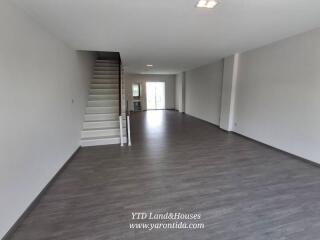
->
146;82;166;110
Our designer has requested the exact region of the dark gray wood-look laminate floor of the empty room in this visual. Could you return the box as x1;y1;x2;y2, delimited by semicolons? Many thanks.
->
8;111;320;240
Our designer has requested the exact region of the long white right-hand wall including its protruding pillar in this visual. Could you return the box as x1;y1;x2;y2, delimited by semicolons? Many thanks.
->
177;26;320;163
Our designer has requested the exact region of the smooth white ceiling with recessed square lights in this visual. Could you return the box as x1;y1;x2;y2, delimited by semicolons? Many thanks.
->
12;0;320;73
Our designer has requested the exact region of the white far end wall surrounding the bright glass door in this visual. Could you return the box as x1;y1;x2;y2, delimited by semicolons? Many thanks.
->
124;74;175;110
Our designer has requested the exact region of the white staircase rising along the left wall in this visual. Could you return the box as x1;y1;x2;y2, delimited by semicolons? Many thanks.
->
81;60;126;146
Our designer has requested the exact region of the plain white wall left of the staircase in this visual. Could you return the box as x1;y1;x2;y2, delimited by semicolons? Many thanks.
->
0;0;94;238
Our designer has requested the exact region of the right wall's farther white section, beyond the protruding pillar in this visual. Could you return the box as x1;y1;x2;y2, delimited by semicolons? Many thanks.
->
185;61;223;125
